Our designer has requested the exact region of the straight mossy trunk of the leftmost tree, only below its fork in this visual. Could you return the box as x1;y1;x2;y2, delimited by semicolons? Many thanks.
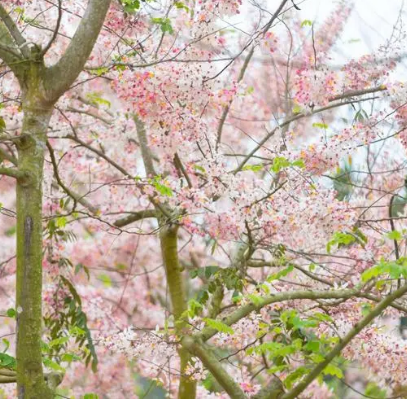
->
16;104;54;399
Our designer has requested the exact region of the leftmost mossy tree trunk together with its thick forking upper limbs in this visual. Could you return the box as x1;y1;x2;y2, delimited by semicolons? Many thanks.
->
0;0;110;399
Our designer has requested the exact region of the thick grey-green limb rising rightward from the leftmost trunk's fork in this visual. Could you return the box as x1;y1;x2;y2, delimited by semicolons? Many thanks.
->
45;0;110;100
